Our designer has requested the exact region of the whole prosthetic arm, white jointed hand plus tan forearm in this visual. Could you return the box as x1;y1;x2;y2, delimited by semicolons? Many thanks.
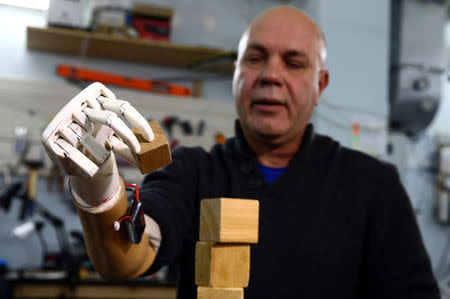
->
41;83;157;279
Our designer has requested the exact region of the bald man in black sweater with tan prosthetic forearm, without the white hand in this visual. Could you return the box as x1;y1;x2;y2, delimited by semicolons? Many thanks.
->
42;6;439;299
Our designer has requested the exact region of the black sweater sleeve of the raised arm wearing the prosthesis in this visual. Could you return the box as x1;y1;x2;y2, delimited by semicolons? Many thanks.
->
140;147;201;273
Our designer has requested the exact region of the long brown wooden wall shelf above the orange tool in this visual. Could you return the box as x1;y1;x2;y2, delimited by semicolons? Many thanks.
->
27;27;236;74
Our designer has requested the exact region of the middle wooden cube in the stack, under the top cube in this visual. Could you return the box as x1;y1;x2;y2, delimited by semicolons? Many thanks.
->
195;242;250;288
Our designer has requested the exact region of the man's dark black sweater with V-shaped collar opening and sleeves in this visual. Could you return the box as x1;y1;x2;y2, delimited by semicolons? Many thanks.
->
140;123;439;299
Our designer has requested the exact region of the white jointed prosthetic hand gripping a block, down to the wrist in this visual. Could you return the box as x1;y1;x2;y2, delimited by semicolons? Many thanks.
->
42;82;154;205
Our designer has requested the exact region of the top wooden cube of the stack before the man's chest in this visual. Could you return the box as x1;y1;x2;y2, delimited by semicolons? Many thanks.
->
200;198;259;243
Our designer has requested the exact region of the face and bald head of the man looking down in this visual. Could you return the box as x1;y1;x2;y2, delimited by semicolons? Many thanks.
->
233;16;328;142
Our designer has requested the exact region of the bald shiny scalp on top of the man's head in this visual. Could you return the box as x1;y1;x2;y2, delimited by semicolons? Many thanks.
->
238;6;327;67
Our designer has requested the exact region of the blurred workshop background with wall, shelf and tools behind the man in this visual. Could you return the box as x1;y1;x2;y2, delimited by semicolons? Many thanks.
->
0;0;450;298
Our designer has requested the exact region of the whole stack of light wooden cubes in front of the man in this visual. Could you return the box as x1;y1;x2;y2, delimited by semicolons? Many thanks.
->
195;198;259;299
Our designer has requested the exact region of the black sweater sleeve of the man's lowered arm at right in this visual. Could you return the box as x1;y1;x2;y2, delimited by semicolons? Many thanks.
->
364;167;440;299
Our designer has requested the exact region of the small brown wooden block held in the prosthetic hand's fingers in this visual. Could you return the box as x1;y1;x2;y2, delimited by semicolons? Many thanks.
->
133;120;172;174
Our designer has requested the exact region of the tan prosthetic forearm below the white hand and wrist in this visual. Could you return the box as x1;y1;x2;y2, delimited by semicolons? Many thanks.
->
71;179;155;280
